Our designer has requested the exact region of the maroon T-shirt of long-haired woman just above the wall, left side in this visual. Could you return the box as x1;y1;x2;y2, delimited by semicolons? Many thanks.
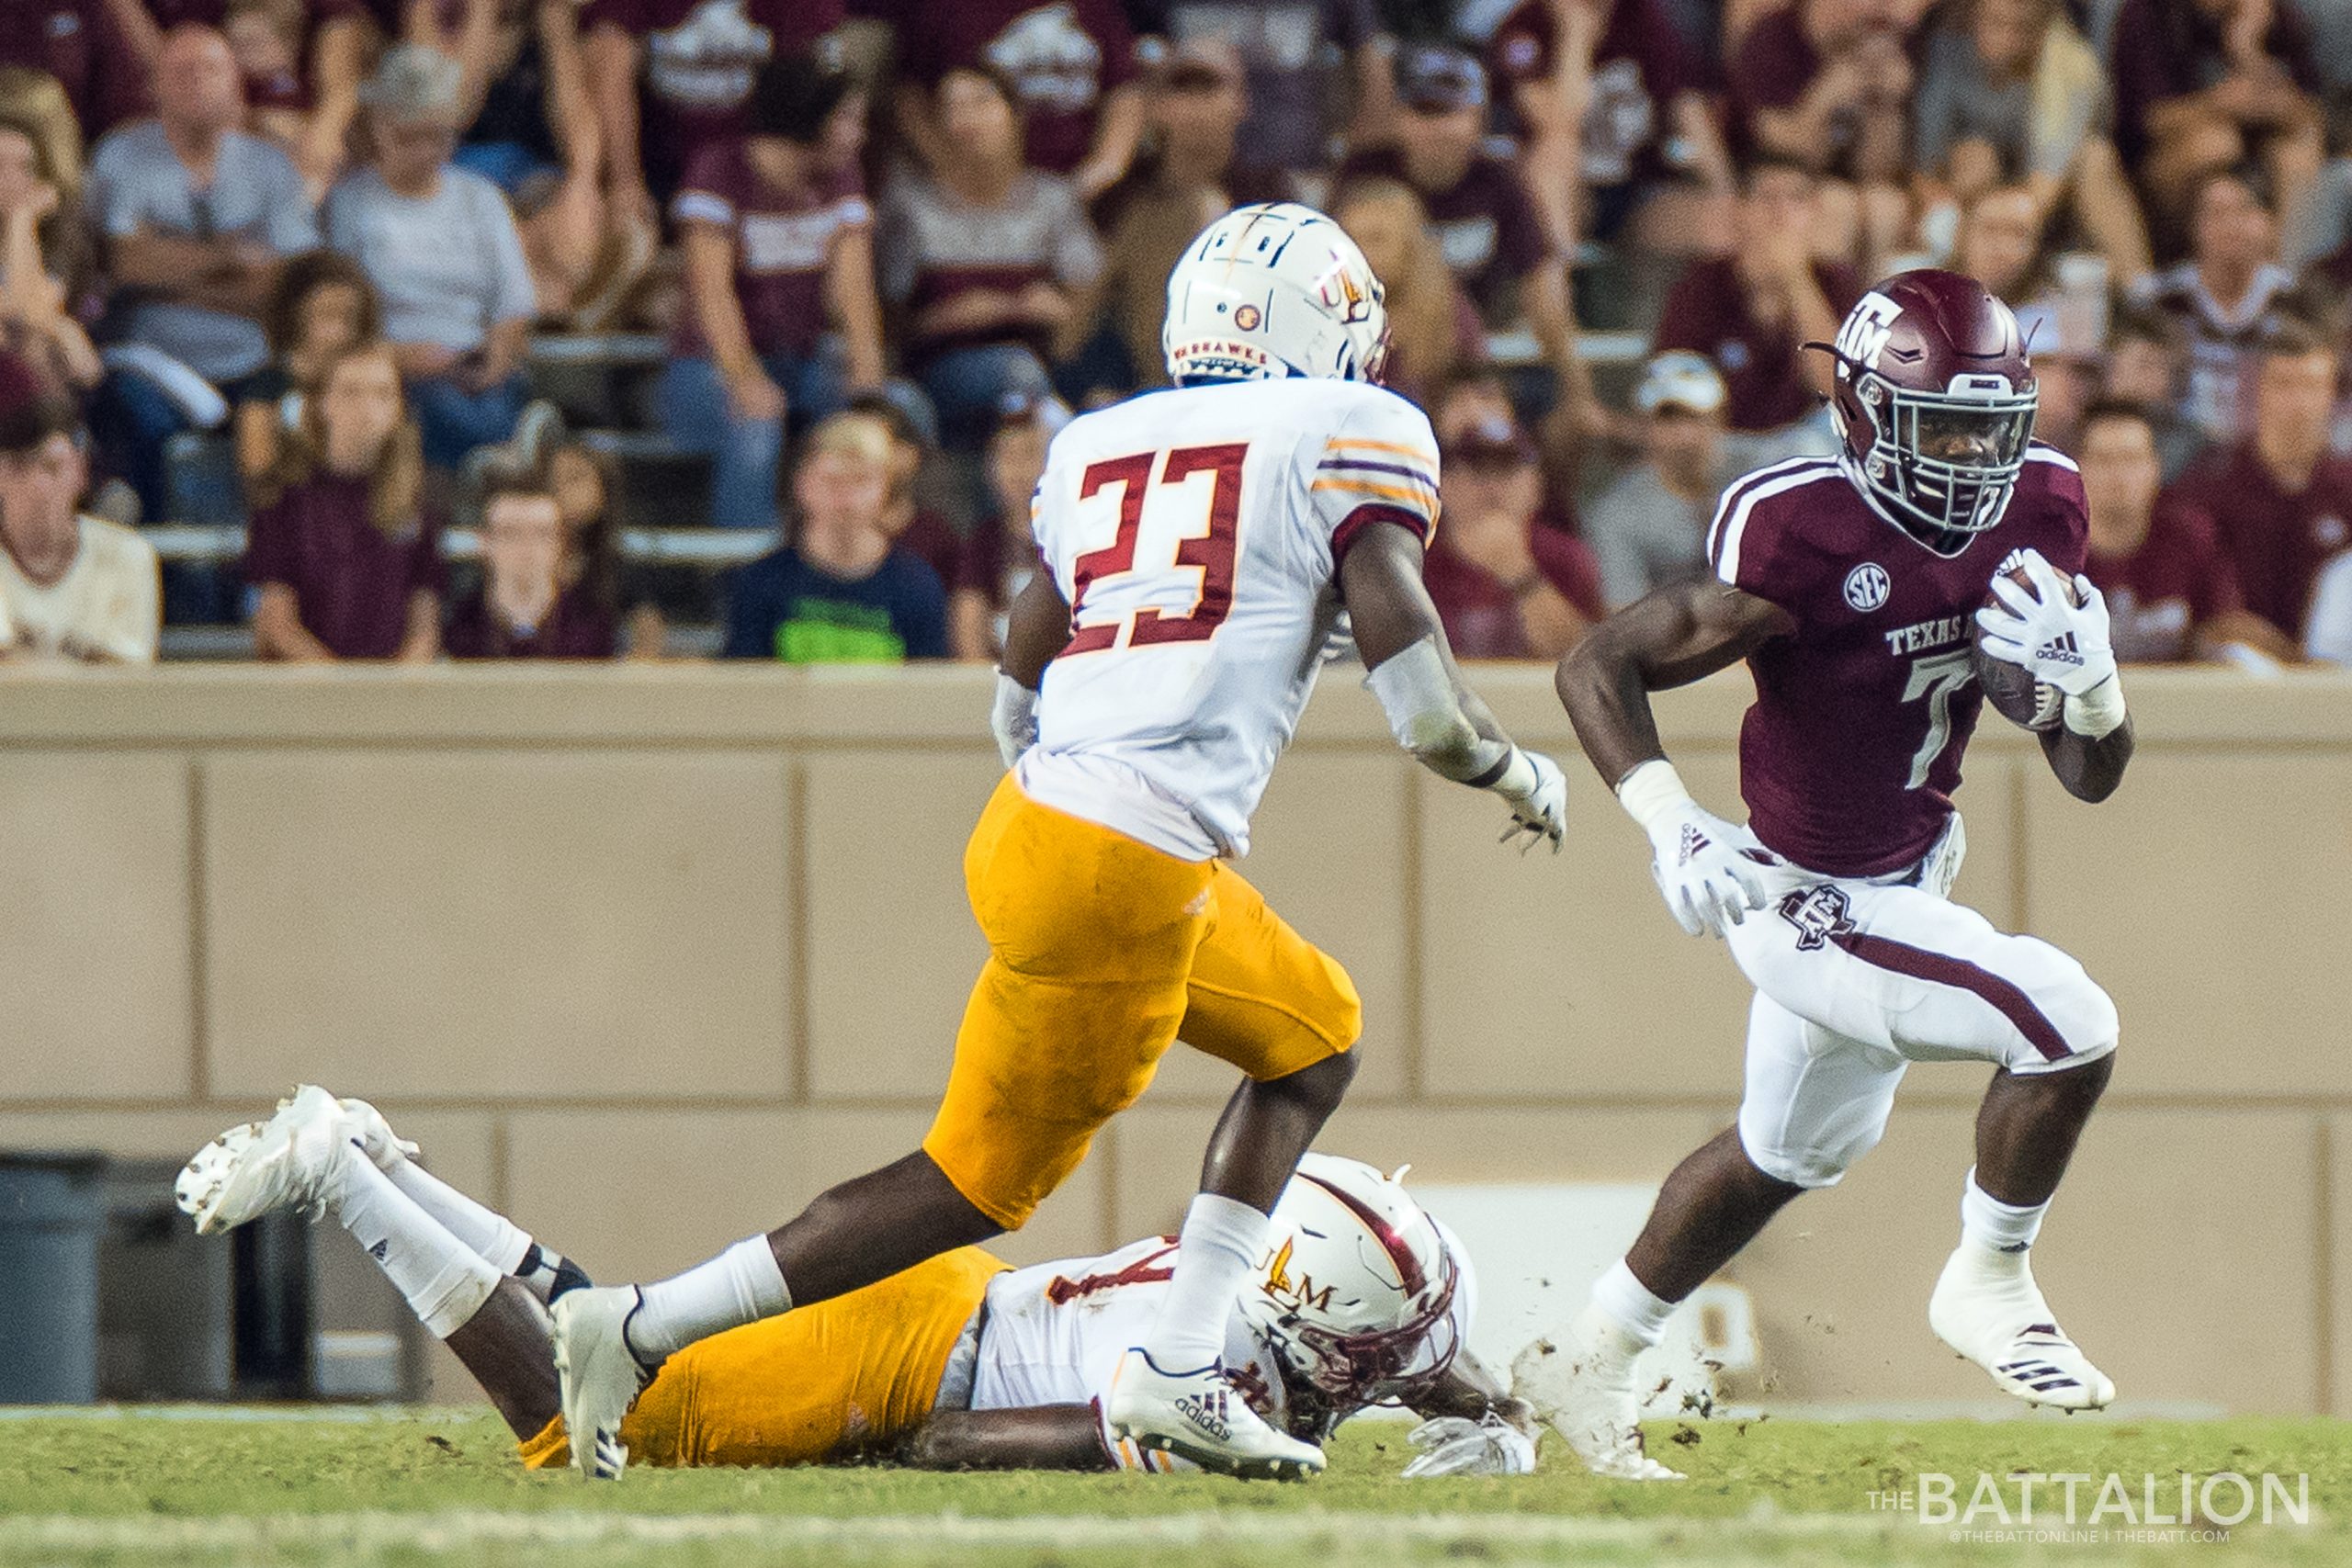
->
244;475;442;659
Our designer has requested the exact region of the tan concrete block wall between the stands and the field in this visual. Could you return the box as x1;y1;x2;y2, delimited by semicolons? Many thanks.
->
0;668;2352;1413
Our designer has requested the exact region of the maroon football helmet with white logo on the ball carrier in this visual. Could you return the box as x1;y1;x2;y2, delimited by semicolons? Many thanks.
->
1814;268;2037;555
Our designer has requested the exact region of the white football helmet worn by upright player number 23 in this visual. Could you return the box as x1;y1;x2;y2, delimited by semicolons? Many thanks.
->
1159;202;1387;386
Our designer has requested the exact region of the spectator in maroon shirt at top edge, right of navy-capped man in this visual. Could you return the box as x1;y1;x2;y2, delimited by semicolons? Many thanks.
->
1487;0;1731;254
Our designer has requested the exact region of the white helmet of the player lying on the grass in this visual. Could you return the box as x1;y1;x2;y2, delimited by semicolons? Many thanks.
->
1242;1155;1467;1413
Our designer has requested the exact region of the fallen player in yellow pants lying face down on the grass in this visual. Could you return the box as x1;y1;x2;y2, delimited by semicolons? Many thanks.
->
176;1086;1536;1476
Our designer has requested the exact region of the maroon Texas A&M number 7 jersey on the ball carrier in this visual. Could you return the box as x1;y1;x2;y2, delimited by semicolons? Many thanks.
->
1708;442;2088;877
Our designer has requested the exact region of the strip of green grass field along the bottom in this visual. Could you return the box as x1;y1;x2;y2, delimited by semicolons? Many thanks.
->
0;1411;2352;1568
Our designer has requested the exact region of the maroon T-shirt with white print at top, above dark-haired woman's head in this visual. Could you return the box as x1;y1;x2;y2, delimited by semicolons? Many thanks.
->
581;0;842;193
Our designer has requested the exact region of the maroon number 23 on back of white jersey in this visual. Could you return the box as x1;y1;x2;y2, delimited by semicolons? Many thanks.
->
1061;442;1249;659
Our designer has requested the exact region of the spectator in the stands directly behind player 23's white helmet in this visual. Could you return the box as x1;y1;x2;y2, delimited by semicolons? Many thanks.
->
1096;38;1298;386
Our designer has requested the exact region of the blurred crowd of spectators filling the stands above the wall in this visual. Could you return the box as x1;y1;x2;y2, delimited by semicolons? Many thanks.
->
0;0;2352;668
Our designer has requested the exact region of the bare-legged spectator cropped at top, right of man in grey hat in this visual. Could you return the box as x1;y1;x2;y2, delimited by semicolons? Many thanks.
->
454;0;630;329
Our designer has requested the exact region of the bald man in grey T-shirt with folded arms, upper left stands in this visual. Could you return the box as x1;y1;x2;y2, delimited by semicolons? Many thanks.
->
85;24;318;517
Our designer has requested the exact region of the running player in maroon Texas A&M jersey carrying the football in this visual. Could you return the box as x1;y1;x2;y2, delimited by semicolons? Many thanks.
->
1520;270;2131;1479
